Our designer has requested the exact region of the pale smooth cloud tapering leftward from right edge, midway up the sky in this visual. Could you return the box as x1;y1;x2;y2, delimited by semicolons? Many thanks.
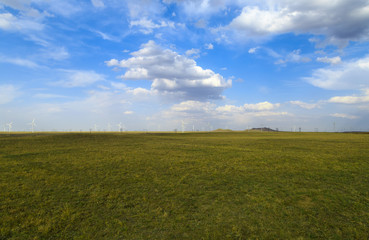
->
304;57;369;90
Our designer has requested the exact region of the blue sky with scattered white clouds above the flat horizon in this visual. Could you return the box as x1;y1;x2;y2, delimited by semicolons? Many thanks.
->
0;0;369;132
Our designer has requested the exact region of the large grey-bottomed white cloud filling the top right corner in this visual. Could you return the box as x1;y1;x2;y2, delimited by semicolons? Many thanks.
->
221;0;369;43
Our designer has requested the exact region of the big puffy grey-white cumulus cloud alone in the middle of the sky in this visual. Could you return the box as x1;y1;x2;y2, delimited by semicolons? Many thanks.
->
106;41;232;100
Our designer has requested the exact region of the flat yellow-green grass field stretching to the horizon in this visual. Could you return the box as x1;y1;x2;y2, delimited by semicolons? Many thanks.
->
0;132;369;239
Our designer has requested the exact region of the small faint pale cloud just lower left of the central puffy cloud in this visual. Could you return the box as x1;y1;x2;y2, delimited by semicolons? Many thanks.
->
55;70;105;88
